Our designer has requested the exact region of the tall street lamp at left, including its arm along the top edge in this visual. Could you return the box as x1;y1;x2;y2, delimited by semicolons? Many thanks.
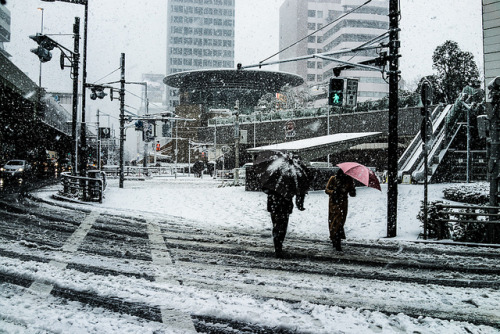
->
42;0;89;176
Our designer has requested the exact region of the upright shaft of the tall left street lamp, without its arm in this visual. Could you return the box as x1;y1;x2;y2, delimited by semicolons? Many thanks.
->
80;1;89;177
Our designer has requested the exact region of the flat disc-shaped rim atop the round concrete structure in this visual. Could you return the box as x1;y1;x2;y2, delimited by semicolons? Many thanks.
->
163;69;304;92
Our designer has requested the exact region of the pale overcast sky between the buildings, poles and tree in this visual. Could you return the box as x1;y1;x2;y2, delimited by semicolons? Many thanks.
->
1;0;483;153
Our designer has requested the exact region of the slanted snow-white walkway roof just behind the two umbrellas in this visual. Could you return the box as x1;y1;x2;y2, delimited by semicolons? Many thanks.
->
247;132;382;161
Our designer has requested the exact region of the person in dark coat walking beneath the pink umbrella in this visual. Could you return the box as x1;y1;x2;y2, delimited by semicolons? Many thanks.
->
325;169;356;251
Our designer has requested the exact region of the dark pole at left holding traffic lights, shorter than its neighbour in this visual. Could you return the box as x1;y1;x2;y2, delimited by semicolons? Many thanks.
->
71;17;80;176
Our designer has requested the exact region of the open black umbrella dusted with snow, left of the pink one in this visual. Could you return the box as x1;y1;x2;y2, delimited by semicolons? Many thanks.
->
254;151;310;197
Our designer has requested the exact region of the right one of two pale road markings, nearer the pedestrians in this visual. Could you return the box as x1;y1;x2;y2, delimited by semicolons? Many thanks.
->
147;221;197;333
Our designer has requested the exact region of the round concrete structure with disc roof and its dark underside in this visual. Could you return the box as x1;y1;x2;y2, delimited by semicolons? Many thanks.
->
163;69;304;111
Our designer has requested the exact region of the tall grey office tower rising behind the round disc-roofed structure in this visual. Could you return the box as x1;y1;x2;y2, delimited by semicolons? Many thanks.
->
166;0;235;109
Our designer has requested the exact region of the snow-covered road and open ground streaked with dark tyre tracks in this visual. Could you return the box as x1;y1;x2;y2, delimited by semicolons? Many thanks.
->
0;180;500;333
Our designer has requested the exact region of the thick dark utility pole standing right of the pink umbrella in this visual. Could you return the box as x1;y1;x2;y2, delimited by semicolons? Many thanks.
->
387;0;401;238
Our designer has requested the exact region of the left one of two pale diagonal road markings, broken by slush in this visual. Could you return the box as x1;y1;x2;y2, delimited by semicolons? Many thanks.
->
25;211;99;296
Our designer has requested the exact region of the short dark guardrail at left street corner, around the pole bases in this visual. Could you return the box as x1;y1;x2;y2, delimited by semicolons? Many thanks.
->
60;171;106;203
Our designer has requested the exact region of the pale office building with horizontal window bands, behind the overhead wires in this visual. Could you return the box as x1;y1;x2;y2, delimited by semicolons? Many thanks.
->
280;0;389;101
